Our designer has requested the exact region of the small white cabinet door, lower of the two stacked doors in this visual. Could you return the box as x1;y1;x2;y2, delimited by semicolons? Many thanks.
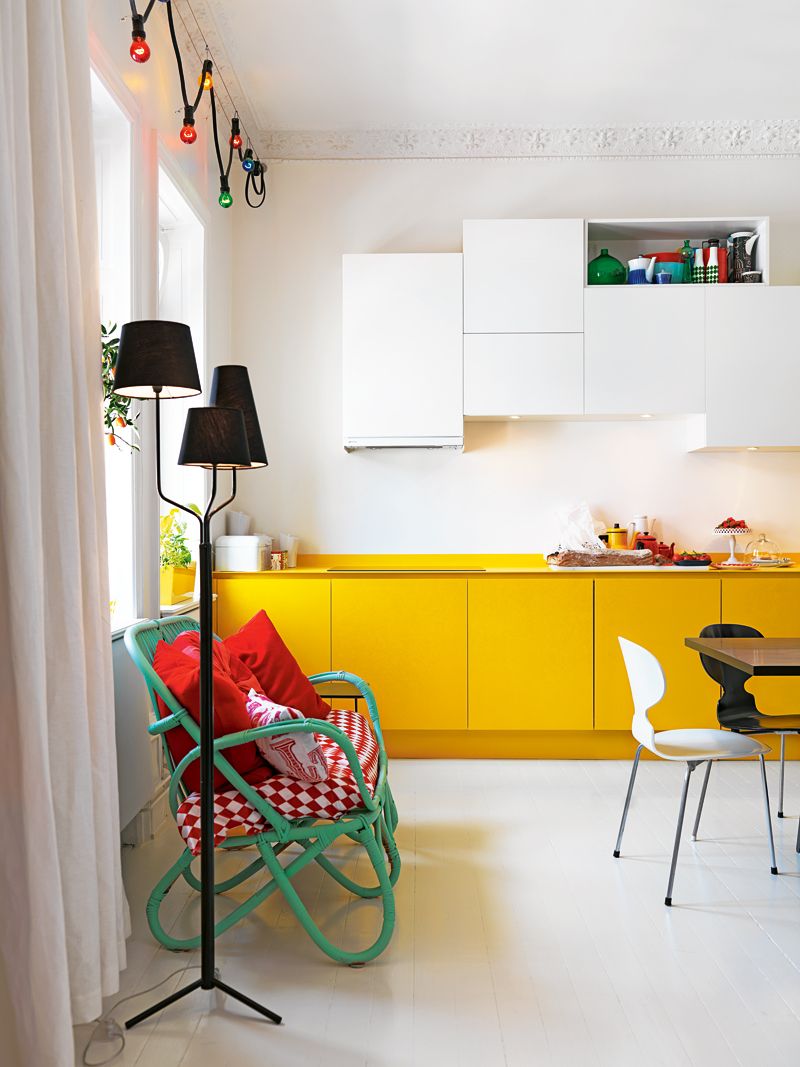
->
464;334;583;417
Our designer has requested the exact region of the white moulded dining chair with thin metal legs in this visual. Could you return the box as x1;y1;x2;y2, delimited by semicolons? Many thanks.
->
614;637;778;907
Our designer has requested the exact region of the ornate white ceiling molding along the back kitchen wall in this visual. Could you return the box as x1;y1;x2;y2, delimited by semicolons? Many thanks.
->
258;118;800;160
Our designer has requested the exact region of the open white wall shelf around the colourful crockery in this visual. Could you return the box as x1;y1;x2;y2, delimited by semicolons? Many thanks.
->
583;216;769;288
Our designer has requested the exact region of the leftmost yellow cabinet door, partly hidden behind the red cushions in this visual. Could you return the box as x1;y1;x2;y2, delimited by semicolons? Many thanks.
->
214;576;331;674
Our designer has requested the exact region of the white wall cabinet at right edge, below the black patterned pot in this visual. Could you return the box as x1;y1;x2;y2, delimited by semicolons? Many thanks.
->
690;285;800;449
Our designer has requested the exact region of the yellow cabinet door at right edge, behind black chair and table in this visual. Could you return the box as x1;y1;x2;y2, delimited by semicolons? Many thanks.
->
722;574;800;715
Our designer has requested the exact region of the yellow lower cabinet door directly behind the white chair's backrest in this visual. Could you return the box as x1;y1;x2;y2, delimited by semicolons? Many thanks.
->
594;574;721;730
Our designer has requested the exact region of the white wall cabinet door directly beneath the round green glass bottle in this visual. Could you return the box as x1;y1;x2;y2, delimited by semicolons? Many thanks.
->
585;285;706;415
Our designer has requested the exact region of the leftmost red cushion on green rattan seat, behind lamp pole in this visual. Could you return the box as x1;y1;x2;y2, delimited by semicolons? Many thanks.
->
153;641;273;792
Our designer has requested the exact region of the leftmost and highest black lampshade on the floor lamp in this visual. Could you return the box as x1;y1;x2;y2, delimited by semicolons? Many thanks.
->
114;319;201;400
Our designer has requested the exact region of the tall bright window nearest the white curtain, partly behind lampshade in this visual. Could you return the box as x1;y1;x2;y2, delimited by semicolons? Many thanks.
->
92;71;137;630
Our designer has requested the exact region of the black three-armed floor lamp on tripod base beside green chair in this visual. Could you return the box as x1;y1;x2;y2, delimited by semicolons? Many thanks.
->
114;320;281;1030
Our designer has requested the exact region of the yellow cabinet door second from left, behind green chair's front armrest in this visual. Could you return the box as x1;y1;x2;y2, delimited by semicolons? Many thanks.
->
331;577;467;730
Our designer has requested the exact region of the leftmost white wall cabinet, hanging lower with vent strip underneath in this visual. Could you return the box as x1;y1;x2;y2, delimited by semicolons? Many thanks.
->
342;253;464;448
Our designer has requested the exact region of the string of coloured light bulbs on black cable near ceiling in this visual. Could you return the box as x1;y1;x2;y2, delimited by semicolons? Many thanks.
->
129;0;267;208
